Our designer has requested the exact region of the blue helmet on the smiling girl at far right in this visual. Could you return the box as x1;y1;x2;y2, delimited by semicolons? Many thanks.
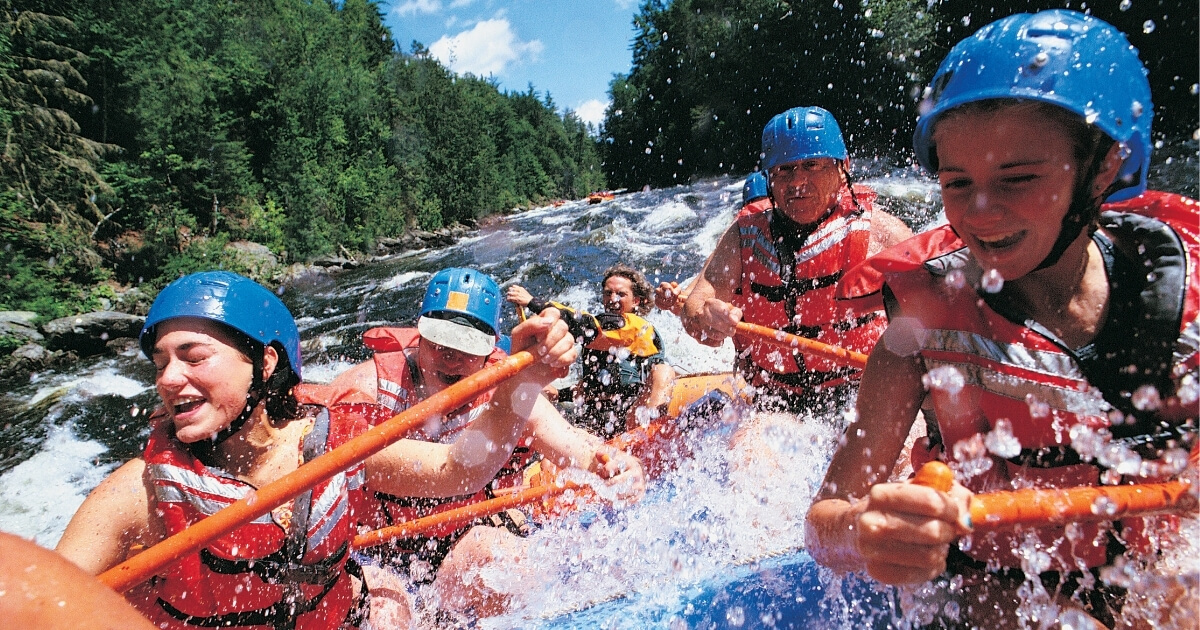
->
916;10;1154;200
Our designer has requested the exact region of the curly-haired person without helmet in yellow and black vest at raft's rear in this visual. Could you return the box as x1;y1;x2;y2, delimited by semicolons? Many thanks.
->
508;264;676;439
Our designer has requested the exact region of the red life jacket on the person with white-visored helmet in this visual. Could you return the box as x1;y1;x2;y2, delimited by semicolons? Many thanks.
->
350;328;533;540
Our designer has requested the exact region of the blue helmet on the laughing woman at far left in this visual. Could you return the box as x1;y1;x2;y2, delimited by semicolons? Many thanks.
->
138;271;300;379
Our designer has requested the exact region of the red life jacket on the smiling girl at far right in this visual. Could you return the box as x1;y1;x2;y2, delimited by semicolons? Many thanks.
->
878;192;1200;570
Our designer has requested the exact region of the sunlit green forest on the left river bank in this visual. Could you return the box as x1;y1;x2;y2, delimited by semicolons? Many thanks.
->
0;0;605;317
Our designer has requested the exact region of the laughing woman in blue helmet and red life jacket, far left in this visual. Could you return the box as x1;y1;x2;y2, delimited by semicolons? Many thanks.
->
58;271;576;630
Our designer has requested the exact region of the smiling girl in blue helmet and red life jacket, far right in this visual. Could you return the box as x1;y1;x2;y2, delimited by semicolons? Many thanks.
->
805;11;1200;628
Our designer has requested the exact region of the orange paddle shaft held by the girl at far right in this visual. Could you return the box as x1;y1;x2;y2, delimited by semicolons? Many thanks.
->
913;462;1198;532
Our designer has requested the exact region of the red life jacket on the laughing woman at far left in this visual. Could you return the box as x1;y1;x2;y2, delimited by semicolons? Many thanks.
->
130;406;374;630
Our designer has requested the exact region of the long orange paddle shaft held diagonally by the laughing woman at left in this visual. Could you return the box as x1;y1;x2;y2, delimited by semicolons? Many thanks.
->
98;352;534;593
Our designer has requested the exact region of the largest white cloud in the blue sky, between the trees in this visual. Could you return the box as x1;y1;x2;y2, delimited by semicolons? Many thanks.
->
430;18;545;77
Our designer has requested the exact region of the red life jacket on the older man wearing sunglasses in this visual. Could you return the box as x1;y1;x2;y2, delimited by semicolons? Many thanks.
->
733;186;887;394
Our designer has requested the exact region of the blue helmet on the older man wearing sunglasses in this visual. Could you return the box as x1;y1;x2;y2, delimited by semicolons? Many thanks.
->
762;107;848;170
